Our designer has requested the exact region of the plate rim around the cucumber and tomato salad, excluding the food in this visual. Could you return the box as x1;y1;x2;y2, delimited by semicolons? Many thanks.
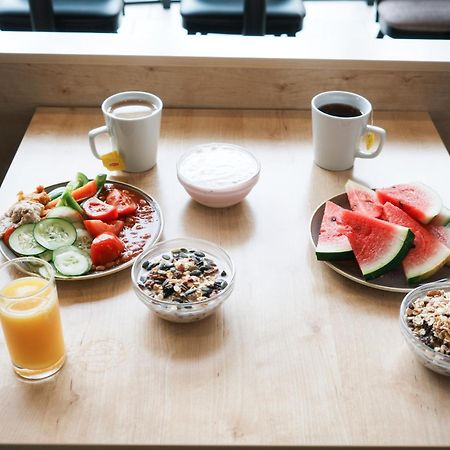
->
0;180;164;281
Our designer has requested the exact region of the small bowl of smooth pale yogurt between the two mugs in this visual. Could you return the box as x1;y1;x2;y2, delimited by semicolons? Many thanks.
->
177;143;261;208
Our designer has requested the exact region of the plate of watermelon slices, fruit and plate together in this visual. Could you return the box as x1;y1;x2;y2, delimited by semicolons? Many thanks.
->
310;180;450;292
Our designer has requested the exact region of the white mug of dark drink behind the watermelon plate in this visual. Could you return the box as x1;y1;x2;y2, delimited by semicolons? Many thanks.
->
311;91;386;170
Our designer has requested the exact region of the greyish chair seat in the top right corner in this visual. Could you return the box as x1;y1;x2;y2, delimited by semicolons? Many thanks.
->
377;0;450;39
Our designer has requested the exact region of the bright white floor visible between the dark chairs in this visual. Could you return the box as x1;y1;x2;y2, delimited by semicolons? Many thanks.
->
119;0;378;39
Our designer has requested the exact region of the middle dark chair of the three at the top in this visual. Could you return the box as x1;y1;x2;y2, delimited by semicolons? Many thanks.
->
180;0;305;36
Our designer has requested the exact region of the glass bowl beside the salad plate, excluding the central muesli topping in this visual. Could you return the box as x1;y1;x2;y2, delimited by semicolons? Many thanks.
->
131;238;235;322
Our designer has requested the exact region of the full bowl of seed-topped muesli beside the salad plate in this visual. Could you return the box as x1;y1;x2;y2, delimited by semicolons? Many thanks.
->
131;238;235;322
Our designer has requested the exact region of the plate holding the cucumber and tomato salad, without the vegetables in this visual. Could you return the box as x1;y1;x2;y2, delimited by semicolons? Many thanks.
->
0;180;164;281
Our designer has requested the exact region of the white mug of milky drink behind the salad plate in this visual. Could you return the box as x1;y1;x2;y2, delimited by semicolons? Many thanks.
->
88;91;163;172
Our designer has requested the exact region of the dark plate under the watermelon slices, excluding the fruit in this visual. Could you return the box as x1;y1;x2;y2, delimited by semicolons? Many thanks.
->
310;192;450;293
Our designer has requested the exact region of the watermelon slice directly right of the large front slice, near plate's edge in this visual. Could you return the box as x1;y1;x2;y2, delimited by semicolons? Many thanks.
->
384;202;450;284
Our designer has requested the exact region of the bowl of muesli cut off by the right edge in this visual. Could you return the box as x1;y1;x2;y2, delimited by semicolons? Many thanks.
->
400;280;450;376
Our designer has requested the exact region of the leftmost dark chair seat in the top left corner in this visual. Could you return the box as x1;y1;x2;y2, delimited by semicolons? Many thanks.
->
0;0;123;33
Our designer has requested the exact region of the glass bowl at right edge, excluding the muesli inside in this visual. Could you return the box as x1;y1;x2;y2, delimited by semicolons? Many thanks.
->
400;280;450;376
